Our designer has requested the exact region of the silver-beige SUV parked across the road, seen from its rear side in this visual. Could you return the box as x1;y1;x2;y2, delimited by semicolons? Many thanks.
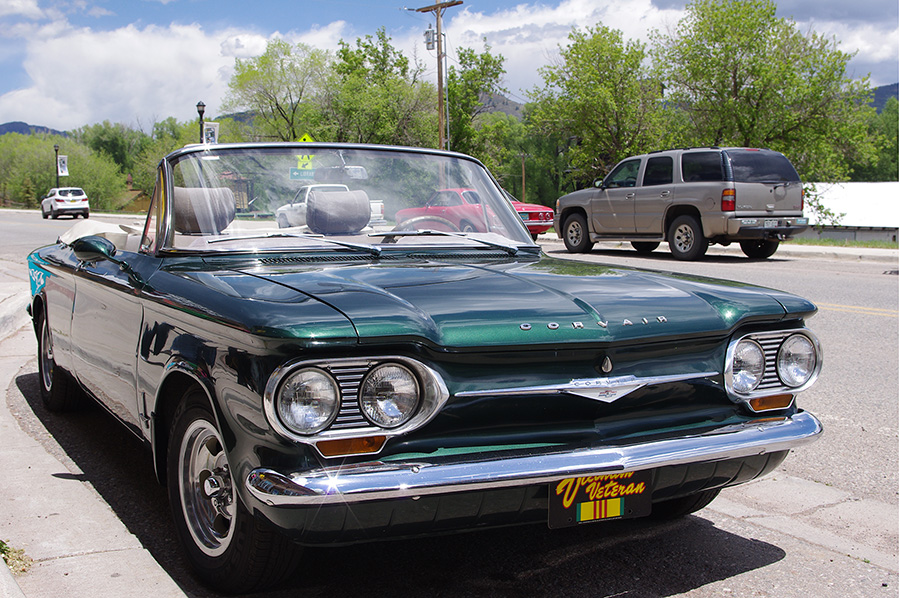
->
553;147;809;260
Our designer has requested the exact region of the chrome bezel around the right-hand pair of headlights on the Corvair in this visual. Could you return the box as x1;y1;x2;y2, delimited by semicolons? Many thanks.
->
724;328;823;411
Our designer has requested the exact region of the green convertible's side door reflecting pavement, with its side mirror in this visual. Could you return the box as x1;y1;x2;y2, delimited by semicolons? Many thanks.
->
72;252;143;434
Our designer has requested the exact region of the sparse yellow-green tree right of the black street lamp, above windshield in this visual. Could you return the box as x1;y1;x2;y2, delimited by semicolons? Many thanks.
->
223;39;332;141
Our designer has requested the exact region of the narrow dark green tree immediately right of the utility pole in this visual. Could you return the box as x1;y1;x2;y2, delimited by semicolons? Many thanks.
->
447;45;506;154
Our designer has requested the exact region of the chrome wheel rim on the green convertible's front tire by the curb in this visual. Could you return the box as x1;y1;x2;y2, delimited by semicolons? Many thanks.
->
178;419;235;556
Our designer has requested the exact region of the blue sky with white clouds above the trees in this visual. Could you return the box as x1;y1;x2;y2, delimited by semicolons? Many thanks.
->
0;0;900;130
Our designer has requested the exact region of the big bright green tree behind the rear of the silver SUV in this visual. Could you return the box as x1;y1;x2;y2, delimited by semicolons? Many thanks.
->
653;0;874;180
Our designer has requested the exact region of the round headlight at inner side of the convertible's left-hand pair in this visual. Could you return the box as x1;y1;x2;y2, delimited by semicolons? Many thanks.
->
359;363;421;428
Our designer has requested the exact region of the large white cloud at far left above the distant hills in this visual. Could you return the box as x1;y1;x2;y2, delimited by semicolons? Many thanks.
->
0;24;243;129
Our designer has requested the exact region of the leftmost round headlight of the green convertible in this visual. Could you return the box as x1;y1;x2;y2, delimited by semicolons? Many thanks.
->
276;368;341;435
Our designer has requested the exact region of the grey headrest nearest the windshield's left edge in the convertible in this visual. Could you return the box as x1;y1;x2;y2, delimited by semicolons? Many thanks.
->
172;187;234;235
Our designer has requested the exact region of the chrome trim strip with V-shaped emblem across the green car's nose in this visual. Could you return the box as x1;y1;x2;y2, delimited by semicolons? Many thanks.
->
454;372;719;403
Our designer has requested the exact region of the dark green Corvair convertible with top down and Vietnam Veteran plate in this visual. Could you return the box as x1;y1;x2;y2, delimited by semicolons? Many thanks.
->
28;143;822;592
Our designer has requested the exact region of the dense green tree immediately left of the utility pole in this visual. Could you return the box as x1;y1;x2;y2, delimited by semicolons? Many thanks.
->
316;28;437;146
